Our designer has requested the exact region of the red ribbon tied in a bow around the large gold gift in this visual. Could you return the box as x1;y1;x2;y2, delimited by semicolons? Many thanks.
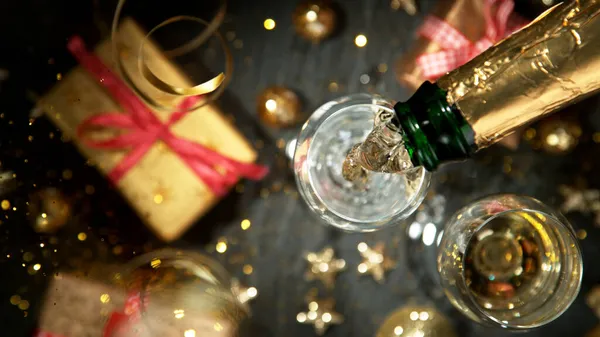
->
68;36;268;196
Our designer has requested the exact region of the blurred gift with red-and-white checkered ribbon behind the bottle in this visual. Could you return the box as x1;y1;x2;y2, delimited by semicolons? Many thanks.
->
395;0;527;148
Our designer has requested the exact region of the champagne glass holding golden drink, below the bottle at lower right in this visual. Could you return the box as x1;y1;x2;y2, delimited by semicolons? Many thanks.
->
438;195;583;330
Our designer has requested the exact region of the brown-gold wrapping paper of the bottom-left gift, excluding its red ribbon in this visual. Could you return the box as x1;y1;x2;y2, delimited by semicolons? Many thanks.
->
38;273;236;337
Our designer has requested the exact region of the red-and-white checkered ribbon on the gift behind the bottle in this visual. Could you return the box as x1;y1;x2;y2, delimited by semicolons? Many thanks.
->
416;0;527;80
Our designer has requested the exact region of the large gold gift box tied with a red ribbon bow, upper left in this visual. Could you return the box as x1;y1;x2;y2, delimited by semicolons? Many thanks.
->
40;19;266;241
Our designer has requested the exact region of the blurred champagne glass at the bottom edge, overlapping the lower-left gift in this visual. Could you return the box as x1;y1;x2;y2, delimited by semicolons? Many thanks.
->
104;249;249;337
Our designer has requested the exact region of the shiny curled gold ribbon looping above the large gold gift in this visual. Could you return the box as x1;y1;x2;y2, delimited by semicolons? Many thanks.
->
111;0;233;111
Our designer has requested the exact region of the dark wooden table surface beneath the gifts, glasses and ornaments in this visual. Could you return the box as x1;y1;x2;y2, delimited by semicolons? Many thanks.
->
0;0;600;337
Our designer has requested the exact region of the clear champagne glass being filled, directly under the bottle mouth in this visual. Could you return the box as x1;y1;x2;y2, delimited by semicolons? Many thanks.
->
294;94;431;232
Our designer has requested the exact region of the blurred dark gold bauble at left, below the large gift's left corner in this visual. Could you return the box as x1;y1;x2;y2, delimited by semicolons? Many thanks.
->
28;187;71;233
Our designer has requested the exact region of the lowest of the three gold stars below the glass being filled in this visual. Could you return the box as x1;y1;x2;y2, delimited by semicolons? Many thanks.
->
296;298;344;336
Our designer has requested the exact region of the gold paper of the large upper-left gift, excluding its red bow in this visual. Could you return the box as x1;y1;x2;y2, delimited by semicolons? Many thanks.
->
40;20;257;241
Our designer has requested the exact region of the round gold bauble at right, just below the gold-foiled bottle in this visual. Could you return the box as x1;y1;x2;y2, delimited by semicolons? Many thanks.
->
525;117;582;155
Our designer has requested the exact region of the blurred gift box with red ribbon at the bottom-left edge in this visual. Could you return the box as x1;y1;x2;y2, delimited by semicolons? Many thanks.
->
34;273;237;337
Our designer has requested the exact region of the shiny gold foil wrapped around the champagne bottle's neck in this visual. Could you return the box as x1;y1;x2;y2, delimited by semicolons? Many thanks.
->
437;0;600;148
